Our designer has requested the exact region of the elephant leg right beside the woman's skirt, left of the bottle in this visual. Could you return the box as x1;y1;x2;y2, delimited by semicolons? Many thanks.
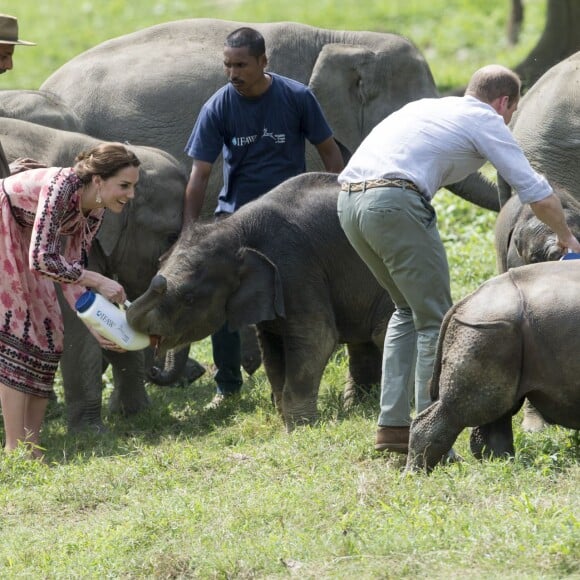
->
57;285;105;432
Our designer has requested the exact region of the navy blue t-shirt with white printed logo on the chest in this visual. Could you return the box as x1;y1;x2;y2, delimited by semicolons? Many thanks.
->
185;73;332;213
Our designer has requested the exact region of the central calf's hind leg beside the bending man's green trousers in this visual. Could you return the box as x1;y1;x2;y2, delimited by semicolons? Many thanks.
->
343;342;383;409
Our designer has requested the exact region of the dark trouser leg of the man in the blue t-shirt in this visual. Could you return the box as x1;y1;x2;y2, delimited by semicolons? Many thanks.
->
211;323;243;395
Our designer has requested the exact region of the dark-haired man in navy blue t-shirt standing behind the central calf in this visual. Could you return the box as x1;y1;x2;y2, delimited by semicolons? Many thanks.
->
183;27;344;407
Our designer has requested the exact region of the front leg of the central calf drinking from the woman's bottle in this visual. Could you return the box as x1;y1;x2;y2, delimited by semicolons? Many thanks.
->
282;324;338;432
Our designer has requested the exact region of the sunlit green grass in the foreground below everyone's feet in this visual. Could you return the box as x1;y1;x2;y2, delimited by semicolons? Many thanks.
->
0;370;580;578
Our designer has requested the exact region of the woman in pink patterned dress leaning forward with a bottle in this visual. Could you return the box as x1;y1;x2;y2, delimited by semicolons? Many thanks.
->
0;143;140;458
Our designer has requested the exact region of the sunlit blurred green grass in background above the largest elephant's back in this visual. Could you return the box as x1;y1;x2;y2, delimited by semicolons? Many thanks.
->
1;0;546;91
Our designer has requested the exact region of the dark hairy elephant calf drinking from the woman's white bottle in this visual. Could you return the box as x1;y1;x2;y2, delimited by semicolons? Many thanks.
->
127;173;394;430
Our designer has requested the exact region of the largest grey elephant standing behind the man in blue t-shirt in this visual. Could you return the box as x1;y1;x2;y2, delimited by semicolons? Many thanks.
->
41;18;499;215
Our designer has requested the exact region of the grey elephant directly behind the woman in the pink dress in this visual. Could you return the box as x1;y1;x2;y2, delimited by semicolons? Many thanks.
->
0;118;186;430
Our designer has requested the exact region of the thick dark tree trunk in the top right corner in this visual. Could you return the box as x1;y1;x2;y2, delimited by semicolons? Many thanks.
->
514;0;580;90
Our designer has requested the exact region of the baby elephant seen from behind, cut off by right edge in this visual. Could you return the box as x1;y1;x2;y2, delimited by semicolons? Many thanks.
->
406;260;580;471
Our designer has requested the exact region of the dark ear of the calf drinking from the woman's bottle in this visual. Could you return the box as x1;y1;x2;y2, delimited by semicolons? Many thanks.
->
226;248;286;331
